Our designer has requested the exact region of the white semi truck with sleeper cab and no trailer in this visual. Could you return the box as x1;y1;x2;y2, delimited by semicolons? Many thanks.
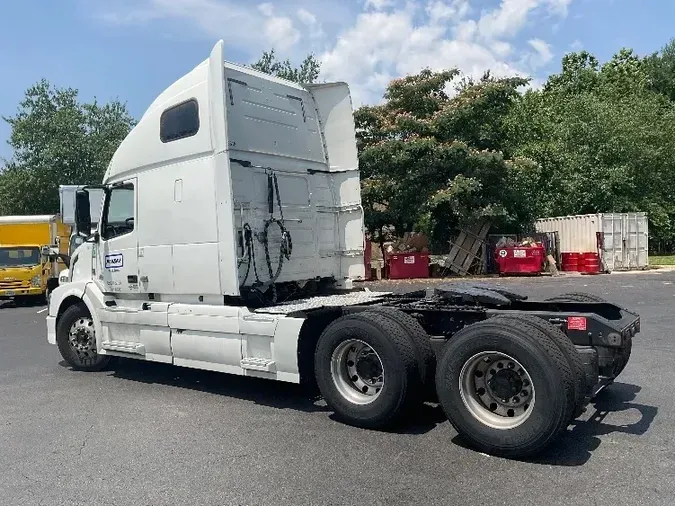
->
46;41;640;457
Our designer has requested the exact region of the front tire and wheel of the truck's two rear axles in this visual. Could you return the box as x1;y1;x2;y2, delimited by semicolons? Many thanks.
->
314;311;420;429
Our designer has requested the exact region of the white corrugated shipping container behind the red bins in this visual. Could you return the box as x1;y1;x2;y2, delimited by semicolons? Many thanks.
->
535;213;649;271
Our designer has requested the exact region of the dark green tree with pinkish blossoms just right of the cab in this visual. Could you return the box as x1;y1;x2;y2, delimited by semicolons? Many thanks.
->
355;69;534;248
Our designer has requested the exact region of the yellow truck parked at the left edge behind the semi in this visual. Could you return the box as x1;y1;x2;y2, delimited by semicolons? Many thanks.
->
0;214;70;302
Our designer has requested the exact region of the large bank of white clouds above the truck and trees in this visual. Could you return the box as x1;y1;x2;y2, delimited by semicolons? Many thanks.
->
93;0;572;105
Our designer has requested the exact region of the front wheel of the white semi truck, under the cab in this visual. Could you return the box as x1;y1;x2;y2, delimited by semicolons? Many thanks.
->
56;304;111;371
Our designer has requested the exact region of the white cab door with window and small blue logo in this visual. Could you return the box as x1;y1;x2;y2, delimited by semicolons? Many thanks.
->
96;178;140;294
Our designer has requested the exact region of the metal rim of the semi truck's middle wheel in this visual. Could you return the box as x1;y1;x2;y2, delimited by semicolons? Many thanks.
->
330;339;384;405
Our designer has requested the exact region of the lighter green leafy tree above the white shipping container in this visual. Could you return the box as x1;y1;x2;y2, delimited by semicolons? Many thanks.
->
506;49;675;249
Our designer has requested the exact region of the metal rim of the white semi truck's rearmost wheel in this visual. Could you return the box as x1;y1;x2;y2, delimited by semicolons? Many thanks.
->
459;351;535;430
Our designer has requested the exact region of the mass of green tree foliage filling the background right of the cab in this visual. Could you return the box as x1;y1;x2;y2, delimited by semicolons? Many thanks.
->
362;39;675;248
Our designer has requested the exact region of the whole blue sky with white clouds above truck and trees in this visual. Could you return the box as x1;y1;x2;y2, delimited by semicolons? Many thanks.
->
0;0;675;157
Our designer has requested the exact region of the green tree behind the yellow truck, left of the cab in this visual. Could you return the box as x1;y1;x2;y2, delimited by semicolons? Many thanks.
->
0;79;135;214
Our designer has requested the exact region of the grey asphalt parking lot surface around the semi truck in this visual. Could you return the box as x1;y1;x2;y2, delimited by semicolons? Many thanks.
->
0;272;675;506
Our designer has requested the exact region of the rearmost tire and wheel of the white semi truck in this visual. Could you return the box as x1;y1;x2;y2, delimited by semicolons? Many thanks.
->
436;316;575;458
